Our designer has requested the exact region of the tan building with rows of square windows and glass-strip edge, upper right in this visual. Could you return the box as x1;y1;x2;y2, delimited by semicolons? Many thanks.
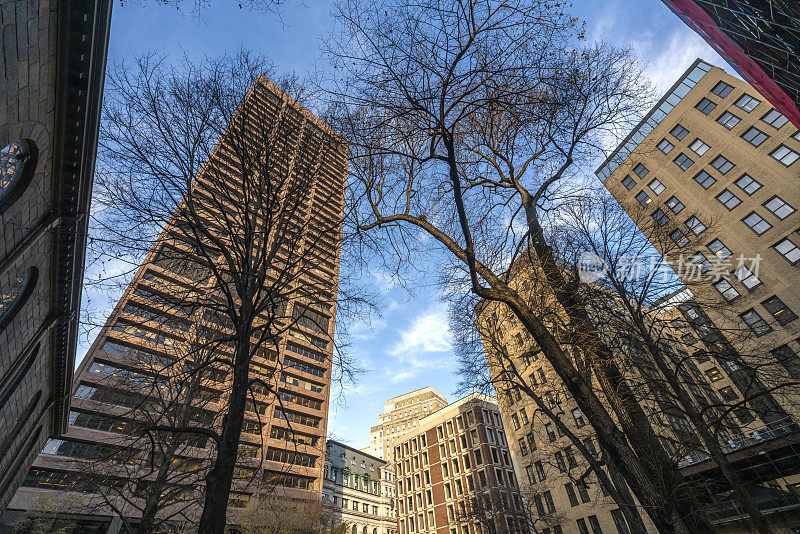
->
597;60;800;418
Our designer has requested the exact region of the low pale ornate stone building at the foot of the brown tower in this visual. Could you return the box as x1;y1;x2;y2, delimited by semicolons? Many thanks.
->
322;440;397;534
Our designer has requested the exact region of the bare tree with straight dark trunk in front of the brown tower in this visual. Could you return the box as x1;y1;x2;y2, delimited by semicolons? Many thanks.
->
93;51;359;532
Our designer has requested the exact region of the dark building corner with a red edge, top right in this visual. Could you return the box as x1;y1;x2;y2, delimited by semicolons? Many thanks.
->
662;0;800;128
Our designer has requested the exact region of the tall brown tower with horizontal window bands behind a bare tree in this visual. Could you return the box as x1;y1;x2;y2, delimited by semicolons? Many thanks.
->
3;77;347;523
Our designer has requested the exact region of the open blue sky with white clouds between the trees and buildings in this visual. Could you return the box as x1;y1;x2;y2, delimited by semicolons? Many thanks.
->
83;0;731;447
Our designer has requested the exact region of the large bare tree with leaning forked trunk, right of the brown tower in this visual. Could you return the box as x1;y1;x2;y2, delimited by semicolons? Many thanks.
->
328;0;709;532
